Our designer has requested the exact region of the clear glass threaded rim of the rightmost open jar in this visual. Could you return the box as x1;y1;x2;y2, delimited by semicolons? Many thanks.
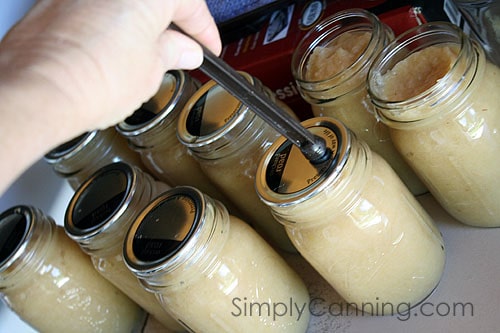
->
366;22;479;127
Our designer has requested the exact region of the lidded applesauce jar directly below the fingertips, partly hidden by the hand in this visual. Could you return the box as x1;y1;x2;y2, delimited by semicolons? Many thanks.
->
116;70;226;201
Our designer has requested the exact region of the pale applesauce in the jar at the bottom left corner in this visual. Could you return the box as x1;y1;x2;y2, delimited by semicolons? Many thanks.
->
2;227;145;333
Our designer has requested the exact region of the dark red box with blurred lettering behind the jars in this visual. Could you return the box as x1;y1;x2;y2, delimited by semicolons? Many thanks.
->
192;0;425;120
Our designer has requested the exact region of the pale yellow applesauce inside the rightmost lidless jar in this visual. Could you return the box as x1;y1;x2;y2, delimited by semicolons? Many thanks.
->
374;46;500;227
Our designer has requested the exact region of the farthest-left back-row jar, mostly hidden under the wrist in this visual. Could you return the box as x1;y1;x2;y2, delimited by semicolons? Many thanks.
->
45;127;143;190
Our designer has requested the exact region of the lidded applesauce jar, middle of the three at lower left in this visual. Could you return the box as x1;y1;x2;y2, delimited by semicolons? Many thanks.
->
64;162;183;331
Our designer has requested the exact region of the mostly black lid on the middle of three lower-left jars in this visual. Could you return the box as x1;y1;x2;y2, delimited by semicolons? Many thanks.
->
64;162;134;239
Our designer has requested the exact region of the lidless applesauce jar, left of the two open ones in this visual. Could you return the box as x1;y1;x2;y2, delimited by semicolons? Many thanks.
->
292;9;427;195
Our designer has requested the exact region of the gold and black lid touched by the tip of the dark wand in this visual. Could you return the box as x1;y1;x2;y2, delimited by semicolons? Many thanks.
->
256;117;351;206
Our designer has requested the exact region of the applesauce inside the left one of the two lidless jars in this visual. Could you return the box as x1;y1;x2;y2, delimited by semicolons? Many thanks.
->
306;31;427;195
